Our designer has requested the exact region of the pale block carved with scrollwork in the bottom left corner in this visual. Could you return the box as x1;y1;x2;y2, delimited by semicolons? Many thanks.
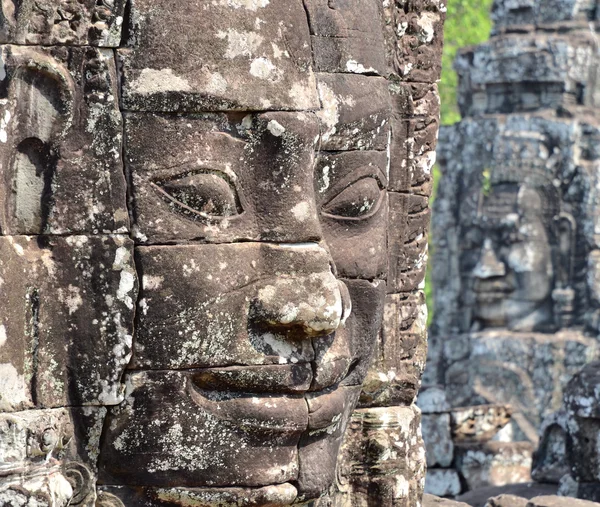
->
0;407;106;506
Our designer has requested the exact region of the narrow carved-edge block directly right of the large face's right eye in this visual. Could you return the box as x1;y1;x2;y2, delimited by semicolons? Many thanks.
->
388;192;431;293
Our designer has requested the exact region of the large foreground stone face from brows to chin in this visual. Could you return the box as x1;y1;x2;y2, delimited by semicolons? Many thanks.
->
101;113;387;497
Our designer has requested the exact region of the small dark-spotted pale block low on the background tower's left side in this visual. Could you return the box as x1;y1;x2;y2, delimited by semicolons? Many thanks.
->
450;405;512;442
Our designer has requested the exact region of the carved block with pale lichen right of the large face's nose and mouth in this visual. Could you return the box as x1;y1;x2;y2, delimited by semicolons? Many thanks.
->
359;292;427;407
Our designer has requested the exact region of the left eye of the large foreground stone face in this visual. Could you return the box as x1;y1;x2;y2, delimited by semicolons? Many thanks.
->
154;170;242;218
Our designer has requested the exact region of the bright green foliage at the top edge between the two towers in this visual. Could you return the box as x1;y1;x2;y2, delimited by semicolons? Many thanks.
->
440;0;492;125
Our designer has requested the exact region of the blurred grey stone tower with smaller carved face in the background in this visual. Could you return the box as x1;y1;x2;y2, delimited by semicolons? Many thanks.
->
422;0;600;494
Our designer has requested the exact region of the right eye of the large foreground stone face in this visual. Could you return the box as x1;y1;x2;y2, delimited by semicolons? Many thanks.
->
323;177;382;218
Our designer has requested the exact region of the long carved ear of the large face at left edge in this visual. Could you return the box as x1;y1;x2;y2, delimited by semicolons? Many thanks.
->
0;50;74;234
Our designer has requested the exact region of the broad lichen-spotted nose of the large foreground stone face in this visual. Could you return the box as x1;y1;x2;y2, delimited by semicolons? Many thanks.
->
253;272;352;337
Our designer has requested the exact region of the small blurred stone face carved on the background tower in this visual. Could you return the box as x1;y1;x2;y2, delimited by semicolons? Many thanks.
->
462;183;554;331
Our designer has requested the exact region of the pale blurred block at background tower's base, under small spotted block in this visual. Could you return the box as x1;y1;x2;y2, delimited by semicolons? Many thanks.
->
455;442;533;490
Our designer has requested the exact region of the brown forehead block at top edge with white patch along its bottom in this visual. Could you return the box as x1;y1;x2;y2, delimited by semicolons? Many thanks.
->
304;0;387;76
